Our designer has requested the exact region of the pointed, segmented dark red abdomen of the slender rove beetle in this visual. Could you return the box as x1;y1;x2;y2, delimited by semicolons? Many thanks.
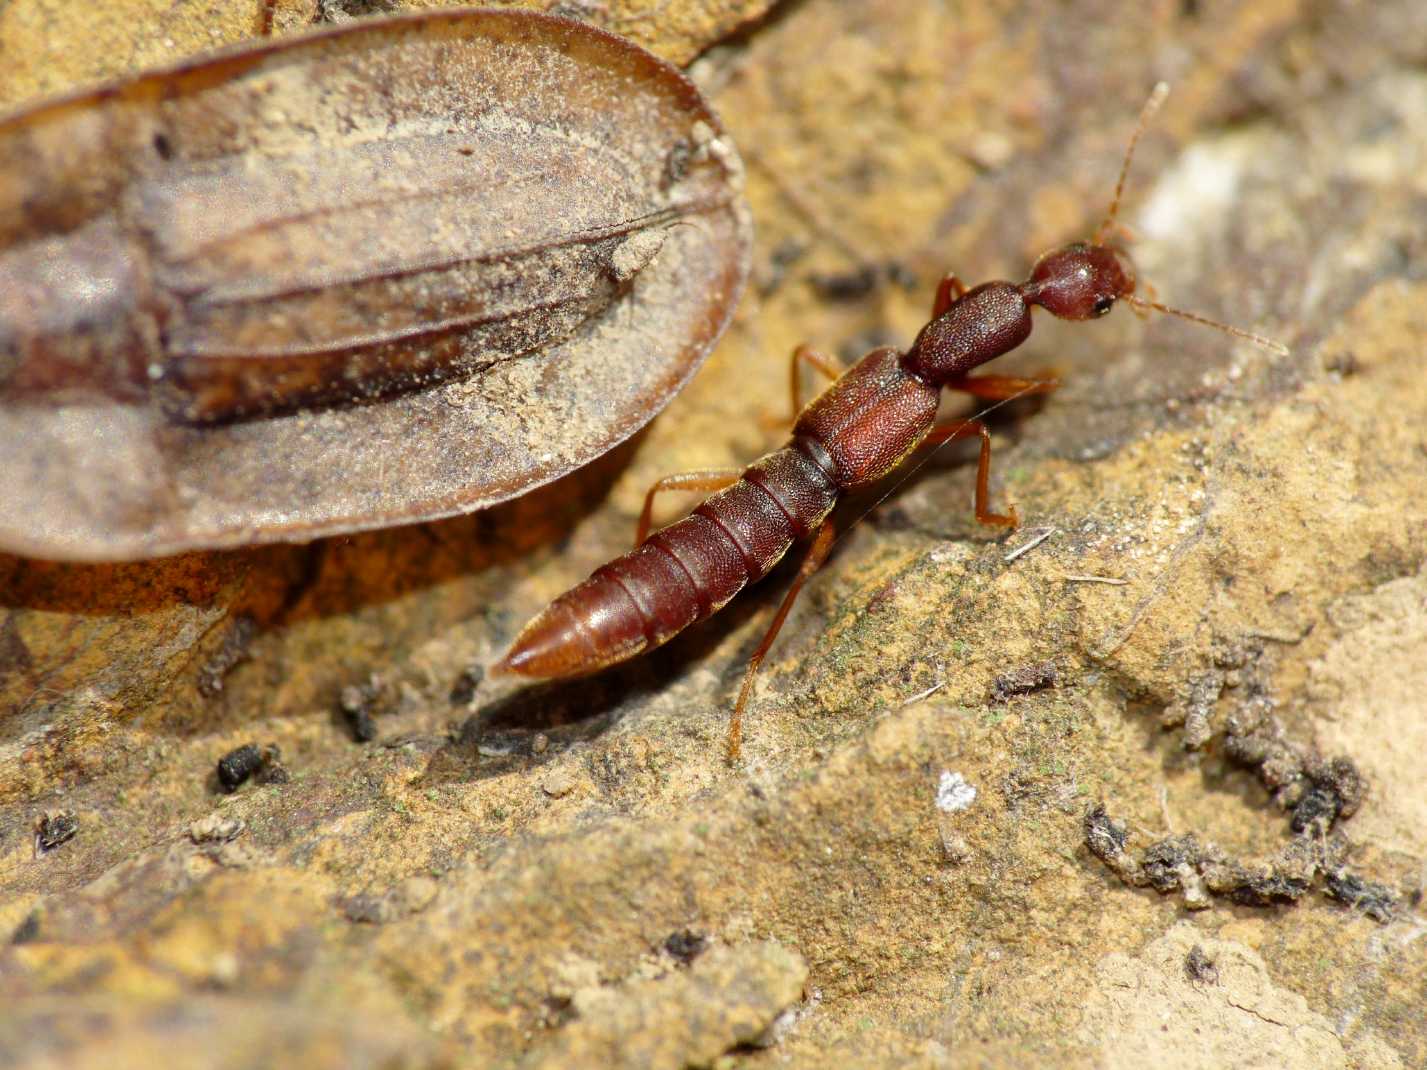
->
498;444;838;679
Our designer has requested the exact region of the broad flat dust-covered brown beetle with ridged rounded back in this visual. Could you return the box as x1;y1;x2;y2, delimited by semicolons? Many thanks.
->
0;10;749;559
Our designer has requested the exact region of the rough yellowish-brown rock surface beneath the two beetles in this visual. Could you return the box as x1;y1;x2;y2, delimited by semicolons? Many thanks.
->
0;0;1427;1067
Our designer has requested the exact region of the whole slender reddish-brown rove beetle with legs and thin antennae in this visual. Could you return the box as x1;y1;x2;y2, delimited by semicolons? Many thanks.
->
497;84;1283;759
